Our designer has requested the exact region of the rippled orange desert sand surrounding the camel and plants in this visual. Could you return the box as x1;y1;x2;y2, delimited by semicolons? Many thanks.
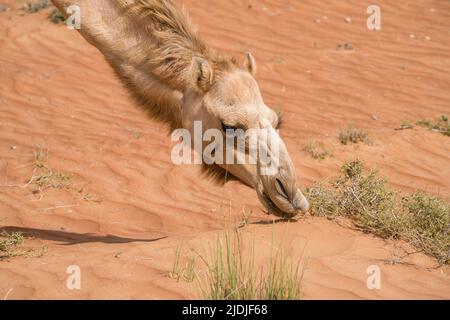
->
0;0;450;299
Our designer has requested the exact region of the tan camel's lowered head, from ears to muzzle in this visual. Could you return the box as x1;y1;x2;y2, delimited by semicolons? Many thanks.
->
181;53;309;218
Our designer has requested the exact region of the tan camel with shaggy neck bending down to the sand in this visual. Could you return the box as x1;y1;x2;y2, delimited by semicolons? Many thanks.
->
52;0;309;218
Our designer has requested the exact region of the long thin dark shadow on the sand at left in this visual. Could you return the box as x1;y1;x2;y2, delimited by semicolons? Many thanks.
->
0;226;167;245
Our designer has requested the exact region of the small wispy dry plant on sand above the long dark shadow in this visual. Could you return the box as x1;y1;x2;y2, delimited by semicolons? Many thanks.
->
27;146;72;193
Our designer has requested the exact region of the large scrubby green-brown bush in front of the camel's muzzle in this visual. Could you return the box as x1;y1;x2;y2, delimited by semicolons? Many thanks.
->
306;160;450;263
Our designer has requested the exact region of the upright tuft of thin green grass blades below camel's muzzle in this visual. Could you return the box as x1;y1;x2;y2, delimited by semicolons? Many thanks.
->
201;229;302;300
